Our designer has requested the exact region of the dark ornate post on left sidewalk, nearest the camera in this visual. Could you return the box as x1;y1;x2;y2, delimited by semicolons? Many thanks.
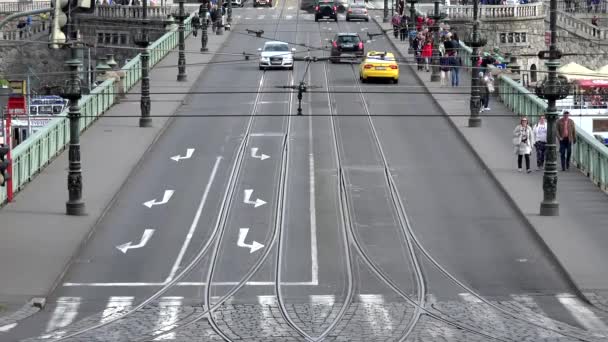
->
64;42;85;216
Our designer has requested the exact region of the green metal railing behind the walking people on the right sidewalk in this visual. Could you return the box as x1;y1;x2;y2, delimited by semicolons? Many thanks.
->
460;42;608;191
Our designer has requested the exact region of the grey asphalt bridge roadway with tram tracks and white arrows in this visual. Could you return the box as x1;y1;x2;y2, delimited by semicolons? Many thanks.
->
0;0;601;341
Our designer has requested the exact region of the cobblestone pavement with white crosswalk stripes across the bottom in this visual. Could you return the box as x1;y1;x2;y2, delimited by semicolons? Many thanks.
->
17;295;608;342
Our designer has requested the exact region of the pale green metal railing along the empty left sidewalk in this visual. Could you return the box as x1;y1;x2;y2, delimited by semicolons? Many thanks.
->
0;15;192;205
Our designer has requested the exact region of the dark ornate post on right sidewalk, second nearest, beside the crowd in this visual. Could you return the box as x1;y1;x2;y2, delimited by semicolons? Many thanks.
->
465;0;486;127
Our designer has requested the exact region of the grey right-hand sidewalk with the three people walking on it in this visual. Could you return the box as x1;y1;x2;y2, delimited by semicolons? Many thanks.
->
379;19;608;300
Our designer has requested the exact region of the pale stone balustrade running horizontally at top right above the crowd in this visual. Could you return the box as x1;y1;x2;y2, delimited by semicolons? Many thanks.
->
443;2;545;21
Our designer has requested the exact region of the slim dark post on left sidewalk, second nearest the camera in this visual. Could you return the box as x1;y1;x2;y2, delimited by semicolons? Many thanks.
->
138;0;152;127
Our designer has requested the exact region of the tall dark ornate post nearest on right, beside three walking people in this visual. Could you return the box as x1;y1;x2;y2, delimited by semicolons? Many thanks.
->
536;0;570;216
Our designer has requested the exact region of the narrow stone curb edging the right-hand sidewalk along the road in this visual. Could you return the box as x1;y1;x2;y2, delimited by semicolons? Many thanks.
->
374;18;605;309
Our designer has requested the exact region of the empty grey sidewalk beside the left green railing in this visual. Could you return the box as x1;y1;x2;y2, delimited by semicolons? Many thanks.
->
0;32;230;316
